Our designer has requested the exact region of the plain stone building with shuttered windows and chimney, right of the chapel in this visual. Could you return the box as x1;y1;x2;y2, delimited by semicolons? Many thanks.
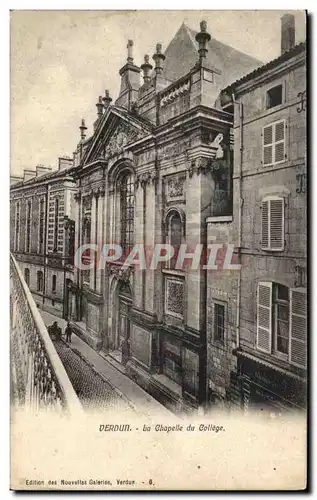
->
208;15;307;413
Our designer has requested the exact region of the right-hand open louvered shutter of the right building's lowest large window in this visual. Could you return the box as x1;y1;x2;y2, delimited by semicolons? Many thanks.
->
290;288;307;367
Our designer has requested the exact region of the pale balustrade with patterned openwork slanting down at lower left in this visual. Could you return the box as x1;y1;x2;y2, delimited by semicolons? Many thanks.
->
10;255;82;414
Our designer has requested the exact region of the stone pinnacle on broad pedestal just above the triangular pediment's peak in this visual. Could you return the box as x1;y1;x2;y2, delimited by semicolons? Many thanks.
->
116;40;141;111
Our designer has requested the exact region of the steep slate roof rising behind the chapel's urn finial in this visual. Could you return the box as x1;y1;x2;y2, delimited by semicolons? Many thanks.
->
163;23;263;87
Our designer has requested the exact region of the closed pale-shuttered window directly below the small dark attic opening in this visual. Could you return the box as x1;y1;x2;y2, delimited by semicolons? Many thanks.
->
262;120;286;166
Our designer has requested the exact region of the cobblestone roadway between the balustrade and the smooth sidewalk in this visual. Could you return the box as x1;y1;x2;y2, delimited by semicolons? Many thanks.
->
54;341;129;410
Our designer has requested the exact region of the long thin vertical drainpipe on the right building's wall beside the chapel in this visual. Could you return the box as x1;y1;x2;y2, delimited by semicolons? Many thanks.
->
232;93;243;347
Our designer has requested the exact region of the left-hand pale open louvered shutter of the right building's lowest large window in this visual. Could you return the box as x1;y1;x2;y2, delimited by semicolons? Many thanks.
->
256;281;272;353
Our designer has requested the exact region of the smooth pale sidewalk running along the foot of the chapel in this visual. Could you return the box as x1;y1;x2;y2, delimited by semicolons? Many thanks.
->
40;310;172;417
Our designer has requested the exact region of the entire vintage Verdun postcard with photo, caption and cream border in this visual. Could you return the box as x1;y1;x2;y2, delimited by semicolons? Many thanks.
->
10;10;308;491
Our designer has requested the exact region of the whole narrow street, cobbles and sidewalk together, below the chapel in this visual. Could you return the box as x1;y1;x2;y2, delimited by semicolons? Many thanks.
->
40;310;171;417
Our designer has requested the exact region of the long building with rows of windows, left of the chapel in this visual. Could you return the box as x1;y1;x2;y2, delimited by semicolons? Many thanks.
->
10;158;75;317
